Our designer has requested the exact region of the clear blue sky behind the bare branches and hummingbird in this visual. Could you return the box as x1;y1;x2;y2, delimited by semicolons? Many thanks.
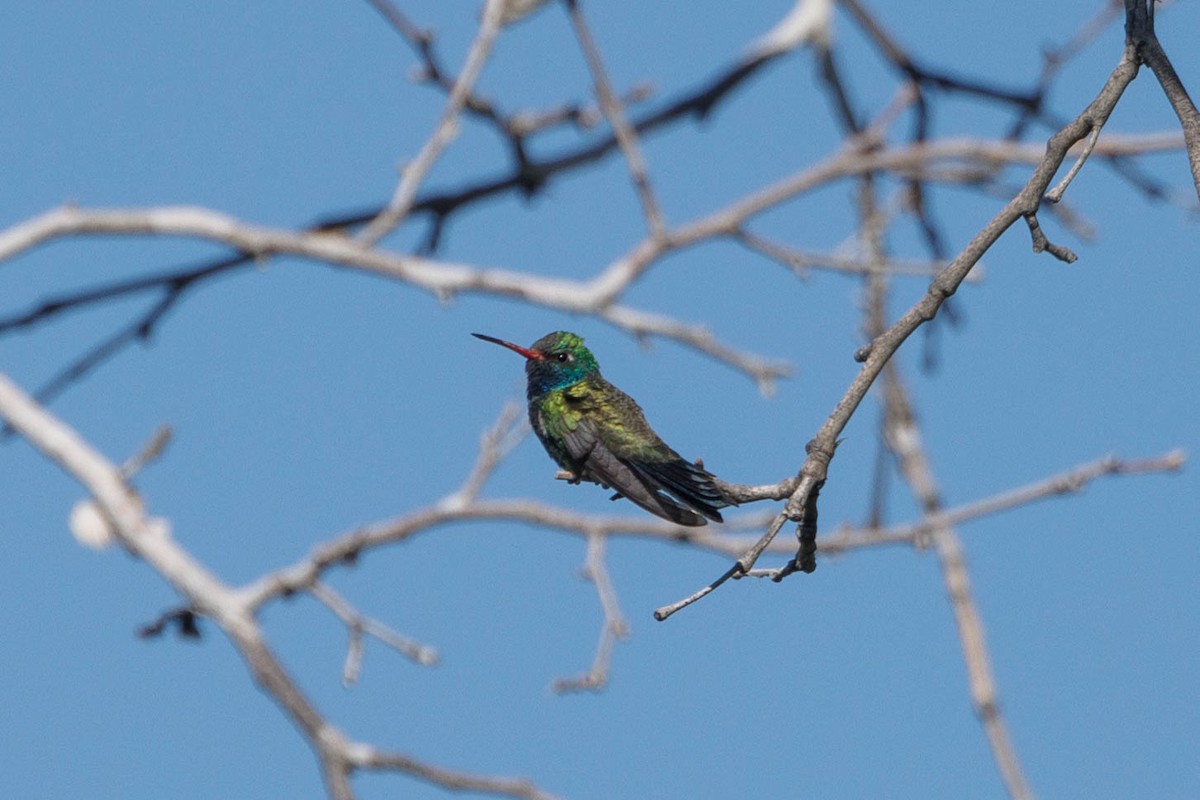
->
0;0;1200;800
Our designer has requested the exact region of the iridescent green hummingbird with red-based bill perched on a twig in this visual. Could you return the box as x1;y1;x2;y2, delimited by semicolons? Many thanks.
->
472;331;730;527
